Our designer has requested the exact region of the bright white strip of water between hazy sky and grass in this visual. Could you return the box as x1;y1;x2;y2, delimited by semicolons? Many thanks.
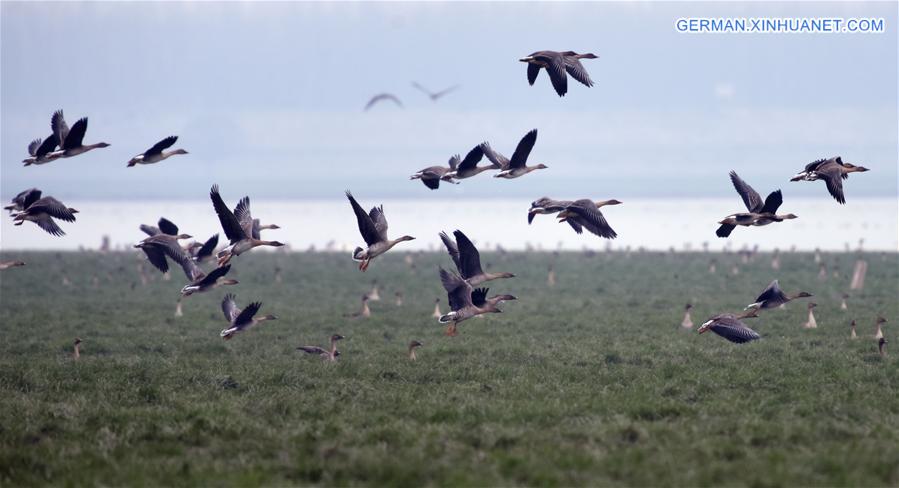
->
0;194;899;252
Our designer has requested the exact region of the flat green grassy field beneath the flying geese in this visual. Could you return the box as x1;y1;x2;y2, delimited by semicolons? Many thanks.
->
0;252;899;486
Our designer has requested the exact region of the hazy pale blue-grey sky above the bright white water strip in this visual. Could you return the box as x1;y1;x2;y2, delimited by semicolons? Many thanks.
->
0;1;899;200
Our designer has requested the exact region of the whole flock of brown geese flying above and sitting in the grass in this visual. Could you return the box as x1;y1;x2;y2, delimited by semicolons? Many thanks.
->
0;51;886;361
